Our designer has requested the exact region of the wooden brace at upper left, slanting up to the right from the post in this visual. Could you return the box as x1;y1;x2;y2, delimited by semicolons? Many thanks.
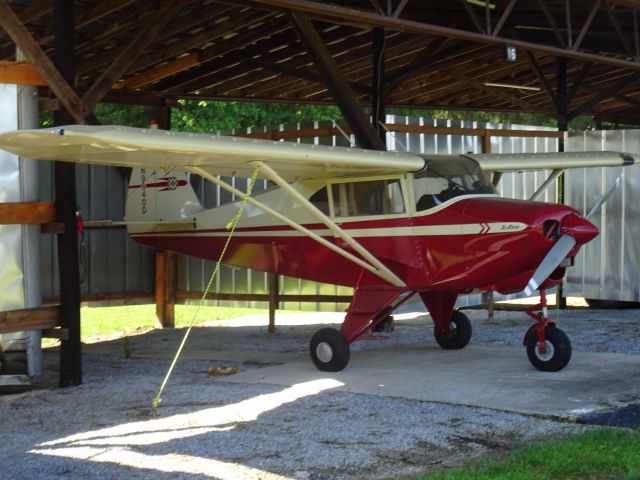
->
81;0;186;111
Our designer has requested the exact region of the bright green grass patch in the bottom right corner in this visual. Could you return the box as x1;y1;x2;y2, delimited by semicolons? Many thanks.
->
416;429;640;480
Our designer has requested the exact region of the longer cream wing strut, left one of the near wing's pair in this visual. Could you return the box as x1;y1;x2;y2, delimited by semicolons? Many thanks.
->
184;162;405;287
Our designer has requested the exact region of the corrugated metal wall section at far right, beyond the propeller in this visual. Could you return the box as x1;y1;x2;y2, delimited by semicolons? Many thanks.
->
566;130;640;301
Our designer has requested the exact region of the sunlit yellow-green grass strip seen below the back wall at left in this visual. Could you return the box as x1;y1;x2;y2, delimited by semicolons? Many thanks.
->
75;305;267;342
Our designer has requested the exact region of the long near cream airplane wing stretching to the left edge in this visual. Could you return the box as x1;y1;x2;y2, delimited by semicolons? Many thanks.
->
0;125;424;181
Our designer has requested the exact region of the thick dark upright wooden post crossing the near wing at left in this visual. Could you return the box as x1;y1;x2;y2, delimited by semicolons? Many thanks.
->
54;0;82;387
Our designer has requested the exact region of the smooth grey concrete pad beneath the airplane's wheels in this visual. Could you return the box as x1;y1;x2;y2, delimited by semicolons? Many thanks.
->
225;345;640;418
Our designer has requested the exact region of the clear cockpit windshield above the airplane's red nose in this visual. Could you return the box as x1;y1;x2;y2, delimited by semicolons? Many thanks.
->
413;155;496;211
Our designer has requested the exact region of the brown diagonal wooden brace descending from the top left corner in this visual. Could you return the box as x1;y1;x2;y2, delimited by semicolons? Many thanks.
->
0;0;85;123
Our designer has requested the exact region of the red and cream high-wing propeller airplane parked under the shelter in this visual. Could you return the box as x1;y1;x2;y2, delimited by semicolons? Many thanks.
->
0;125;635;371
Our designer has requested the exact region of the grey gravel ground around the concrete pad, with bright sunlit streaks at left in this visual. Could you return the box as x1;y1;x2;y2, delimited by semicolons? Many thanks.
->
0;309;640;479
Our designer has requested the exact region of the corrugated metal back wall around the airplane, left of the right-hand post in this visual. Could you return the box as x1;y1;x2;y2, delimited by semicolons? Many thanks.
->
41;115;557;311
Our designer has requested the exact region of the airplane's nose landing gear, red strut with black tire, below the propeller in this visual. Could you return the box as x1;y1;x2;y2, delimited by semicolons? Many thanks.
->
524;289;571;372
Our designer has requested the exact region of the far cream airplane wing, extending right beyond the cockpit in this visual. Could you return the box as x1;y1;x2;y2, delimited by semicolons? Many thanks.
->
464;152;635;173
